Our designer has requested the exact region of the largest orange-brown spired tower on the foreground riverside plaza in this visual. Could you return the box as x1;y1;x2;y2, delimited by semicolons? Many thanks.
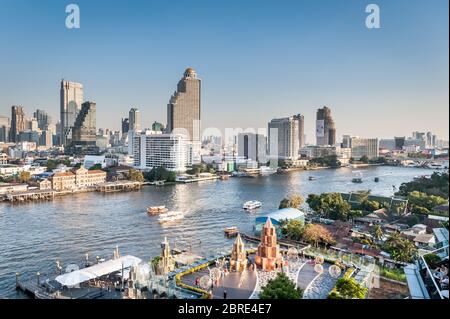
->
255;218;283;271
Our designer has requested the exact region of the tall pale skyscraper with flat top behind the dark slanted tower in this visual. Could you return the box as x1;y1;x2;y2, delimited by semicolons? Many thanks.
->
59;80;83;146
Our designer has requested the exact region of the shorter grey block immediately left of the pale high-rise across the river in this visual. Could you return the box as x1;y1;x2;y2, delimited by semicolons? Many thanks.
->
237;133;267;163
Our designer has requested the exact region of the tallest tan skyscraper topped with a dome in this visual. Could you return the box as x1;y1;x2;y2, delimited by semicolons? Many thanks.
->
167;68;201;144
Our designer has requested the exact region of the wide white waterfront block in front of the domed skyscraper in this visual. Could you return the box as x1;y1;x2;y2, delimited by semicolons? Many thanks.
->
132;131;191;172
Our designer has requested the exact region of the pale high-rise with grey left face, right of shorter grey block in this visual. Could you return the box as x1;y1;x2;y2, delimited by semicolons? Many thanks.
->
268;116;300;159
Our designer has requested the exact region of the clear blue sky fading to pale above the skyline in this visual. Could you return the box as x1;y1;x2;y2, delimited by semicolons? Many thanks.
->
0;0;449;142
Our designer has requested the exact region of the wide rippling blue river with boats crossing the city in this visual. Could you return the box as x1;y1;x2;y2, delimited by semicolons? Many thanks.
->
0;166;442;298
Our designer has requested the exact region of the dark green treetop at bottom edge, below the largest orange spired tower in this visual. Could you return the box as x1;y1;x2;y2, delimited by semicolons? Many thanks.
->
259;273;303;299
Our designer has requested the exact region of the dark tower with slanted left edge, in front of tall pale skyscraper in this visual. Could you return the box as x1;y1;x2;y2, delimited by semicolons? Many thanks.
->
71;102;97;154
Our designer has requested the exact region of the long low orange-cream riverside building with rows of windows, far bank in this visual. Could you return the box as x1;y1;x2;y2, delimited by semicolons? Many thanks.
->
52;167;106;191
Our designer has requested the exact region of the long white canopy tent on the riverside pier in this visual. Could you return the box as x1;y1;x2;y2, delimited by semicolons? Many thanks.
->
55;255;142;287
